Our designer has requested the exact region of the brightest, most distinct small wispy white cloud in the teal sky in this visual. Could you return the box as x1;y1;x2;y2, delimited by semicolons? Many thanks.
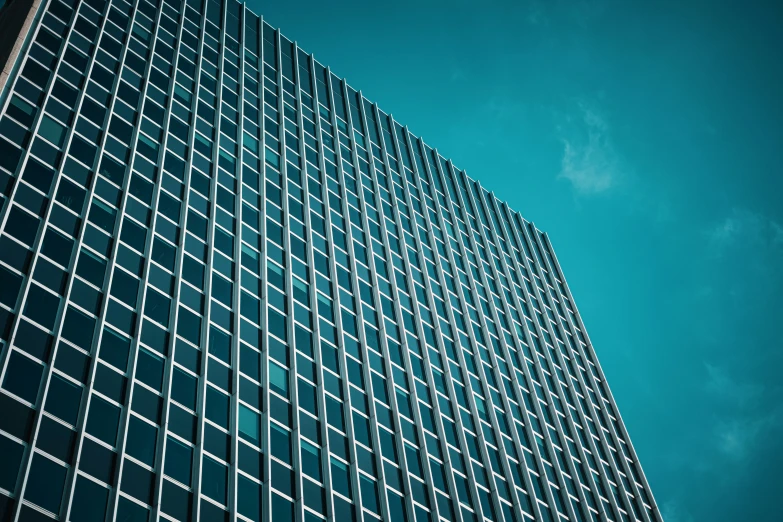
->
558;102;620;196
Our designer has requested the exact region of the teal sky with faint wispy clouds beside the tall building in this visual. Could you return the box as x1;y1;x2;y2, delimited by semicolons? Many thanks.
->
251;0;783;522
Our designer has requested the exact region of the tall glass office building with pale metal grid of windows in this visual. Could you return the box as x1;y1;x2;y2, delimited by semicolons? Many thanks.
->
0;0;661;522
